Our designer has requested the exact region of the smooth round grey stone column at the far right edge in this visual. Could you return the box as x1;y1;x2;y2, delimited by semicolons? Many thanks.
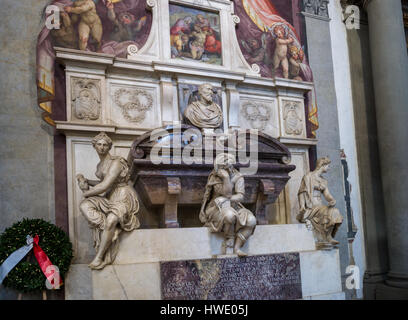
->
365;0;408;292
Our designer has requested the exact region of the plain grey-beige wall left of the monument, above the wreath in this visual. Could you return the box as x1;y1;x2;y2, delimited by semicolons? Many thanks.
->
0;0;55;300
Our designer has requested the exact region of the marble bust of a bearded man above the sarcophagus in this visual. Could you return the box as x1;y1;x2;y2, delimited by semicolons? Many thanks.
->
184;83;223;129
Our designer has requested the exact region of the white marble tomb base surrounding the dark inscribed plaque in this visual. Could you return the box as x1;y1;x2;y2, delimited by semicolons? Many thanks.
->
65;224;344;300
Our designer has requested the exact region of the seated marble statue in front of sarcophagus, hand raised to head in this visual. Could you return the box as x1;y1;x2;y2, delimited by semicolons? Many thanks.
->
200;153;256;256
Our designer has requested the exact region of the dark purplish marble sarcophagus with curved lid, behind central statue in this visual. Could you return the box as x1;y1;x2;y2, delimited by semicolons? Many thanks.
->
128;125;295;228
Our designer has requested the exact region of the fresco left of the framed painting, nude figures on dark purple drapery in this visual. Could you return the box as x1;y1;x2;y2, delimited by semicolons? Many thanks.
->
37;0;152;123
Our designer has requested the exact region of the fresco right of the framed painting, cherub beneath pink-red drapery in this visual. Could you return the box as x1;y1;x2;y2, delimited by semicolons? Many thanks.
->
233;0;319;137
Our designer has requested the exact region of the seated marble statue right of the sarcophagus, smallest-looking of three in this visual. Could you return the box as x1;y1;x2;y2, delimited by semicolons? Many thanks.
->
297;157;343;248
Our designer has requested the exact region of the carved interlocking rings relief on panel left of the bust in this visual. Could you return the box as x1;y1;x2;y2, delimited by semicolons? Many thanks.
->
114;88;153;123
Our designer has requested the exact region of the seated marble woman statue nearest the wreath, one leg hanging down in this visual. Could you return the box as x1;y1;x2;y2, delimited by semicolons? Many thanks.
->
77;132;140;269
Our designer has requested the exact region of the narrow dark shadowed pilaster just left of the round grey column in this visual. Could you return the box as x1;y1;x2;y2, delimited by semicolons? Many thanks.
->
347;10;389;300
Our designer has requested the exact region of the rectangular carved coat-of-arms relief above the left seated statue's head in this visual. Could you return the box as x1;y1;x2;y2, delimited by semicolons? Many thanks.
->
71;77;101;120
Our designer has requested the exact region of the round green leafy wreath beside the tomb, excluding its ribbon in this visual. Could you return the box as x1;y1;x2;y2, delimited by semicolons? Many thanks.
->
0;219;73;292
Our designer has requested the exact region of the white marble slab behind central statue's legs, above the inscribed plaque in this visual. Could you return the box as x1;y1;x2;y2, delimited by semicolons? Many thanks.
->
115;224;315;264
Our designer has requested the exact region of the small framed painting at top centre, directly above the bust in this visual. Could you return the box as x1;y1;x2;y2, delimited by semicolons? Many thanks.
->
169;4;222;65
